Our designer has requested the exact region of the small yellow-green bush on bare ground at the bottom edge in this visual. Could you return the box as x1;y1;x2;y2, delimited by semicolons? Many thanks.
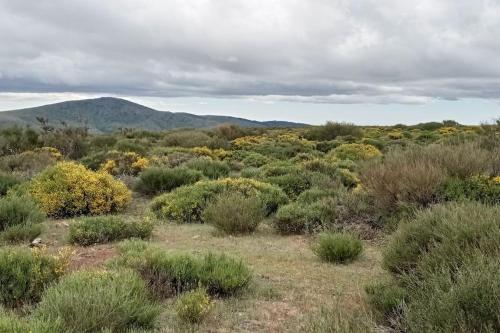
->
175;288;212;324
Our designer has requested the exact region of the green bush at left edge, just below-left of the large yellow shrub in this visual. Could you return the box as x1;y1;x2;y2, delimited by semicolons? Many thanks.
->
0;195;45;232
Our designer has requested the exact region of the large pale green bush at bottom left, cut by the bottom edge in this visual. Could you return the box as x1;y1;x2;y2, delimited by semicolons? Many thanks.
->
34;271;160;333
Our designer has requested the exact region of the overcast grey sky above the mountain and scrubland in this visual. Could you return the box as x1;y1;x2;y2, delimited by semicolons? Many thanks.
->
0;0;500;124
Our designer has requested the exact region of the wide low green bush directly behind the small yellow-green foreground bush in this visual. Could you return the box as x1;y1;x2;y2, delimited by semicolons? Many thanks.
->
115;242;251;297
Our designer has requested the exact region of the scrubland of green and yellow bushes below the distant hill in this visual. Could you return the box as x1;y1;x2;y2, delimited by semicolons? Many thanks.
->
0;121;500;333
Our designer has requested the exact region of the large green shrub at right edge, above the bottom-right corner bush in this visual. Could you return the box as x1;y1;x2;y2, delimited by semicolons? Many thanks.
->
383;202;500;274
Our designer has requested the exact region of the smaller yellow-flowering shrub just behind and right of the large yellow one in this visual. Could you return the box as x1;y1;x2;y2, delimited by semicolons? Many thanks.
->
100;151;150;176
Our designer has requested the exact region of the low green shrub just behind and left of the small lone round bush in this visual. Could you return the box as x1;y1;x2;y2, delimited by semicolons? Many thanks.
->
273;198;337;234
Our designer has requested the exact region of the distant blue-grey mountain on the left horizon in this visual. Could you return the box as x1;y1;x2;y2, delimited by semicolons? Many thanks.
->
0;97;307;133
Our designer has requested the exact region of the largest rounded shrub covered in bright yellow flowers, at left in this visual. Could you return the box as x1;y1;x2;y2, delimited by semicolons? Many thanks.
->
29;162;131;217
